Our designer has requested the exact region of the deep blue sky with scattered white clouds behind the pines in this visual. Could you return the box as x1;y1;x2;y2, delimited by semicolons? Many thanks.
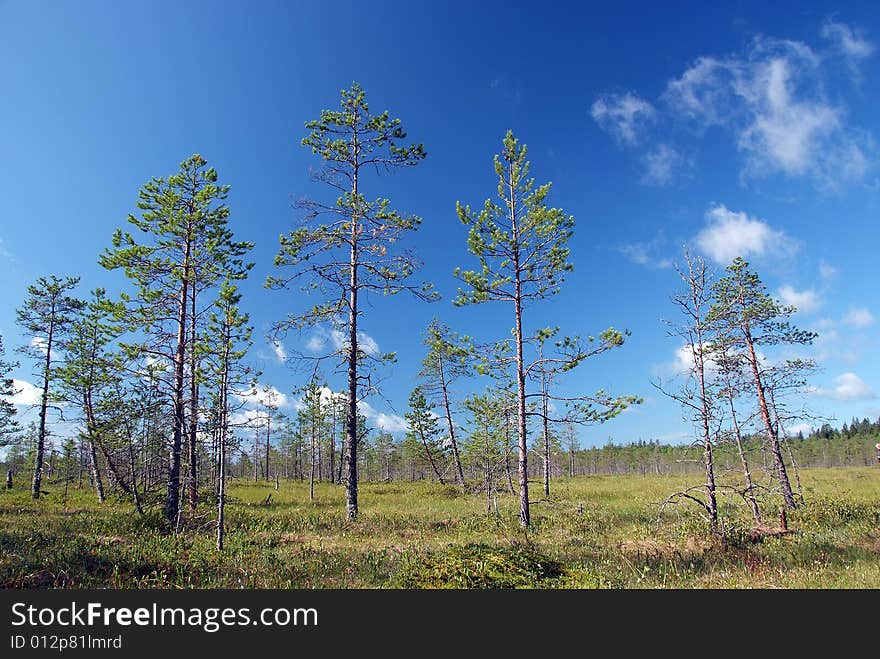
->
0;1;880;445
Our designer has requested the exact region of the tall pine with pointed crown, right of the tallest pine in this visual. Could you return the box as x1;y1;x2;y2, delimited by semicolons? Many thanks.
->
454;131;637;527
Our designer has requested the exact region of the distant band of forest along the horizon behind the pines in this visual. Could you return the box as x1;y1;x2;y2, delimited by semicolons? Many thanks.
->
0;418;880;491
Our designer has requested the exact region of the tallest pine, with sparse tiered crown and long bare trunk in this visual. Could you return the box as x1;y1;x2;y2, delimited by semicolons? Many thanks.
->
266;83;435;520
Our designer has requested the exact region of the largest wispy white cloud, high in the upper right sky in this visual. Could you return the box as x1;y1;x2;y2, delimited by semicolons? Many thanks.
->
663;37;870;188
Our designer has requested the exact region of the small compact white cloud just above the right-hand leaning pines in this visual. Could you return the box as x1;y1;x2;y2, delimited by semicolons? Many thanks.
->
695;205;797;264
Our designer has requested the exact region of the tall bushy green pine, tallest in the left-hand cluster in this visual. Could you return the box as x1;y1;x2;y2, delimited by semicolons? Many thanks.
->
100;154;253;523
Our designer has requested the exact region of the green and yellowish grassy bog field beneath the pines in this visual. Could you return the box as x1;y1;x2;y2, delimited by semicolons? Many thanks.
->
0;467;880;588
